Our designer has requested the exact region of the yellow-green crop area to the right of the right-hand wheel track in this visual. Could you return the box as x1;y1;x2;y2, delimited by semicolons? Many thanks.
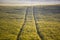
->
34;6;60;40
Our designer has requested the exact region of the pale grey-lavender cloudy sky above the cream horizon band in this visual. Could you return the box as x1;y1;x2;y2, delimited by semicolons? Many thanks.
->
0;0;60;5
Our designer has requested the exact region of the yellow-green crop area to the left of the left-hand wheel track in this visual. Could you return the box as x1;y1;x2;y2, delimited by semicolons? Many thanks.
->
0;7;26;40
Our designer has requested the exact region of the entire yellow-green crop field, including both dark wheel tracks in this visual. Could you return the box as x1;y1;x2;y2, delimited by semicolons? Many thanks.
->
0;6;60;40
